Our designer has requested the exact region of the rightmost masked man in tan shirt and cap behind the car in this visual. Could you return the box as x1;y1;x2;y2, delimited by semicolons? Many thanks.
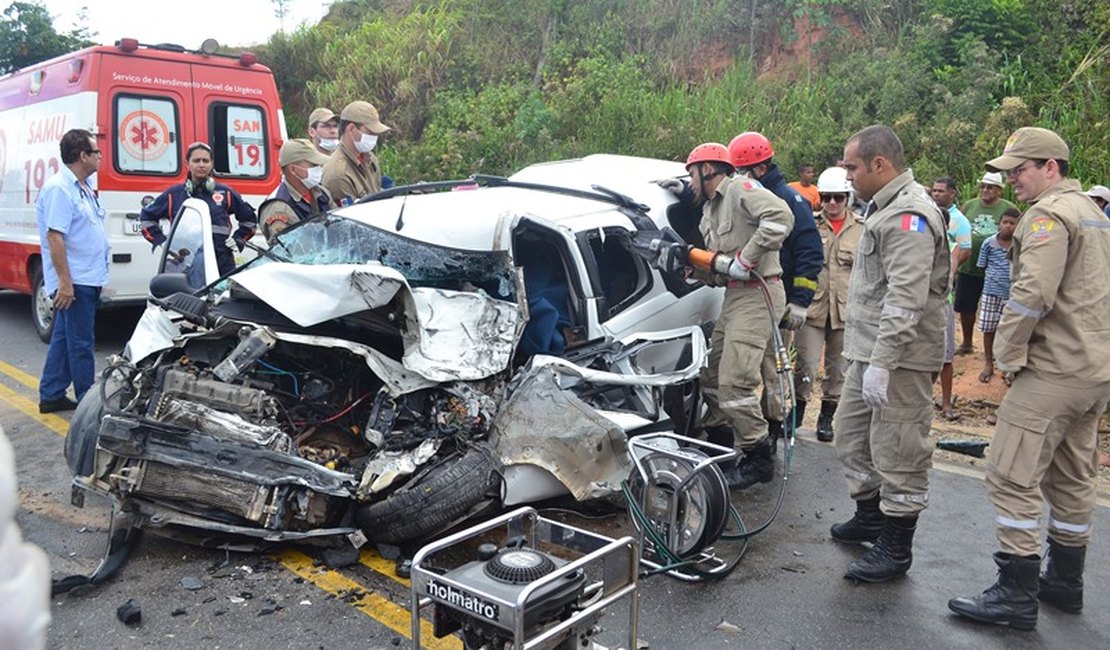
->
322;101;390;205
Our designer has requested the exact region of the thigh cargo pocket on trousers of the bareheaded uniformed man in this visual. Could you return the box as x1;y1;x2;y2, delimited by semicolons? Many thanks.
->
871;404;932;471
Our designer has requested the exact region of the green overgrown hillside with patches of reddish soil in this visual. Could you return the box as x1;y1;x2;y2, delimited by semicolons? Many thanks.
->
263;0;1110;191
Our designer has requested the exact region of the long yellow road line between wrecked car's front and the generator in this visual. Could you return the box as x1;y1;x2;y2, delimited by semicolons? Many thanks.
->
275;550;463;650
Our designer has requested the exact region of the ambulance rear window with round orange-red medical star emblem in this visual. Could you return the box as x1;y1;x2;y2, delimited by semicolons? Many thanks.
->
112;94;181;176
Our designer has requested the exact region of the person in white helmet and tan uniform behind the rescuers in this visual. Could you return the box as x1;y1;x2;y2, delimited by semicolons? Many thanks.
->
794;167;864;443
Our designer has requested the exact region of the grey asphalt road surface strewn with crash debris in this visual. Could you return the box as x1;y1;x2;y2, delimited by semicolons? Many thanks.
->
0;292;1110;649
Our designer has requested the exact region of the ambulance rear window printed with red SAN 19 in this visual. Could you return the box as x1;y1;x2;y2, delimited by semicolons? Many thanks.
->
209;103;270;179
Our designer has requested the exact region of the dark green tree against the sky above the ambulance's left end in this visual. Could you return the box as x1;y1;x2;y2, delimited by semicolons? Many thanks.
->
0;2;92;73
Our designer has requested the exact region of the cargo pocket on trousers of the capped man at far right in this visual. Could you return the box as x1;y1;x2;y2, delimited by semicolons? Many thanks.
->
987;400;1052;488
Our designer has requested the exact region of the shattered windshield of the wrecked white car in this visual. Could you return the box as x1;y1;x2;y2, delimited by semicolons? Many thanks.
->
259;216;516;302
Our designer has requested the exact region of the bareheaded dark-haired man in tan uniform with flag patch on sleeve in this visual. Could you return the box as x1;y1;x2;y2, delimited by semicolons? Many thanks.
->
831;125;949;582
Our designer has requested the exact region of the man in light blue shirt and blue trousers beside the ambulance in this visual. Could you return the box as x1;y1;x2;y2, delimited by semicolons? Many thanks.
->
34;129;109;413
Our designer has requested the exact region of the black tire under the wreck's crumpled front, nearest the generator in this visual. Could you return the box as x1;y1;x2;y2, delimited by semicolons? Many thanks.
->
355;449;501;544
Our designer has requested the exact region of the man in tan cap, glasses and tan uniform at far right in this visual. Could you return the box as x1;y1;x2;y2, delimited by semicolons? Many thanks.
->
948;128;1110;630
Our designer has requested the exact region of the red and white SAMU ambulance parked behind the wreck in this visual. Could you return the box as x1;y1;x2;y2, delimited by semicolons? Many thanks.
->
0;39;285;341
